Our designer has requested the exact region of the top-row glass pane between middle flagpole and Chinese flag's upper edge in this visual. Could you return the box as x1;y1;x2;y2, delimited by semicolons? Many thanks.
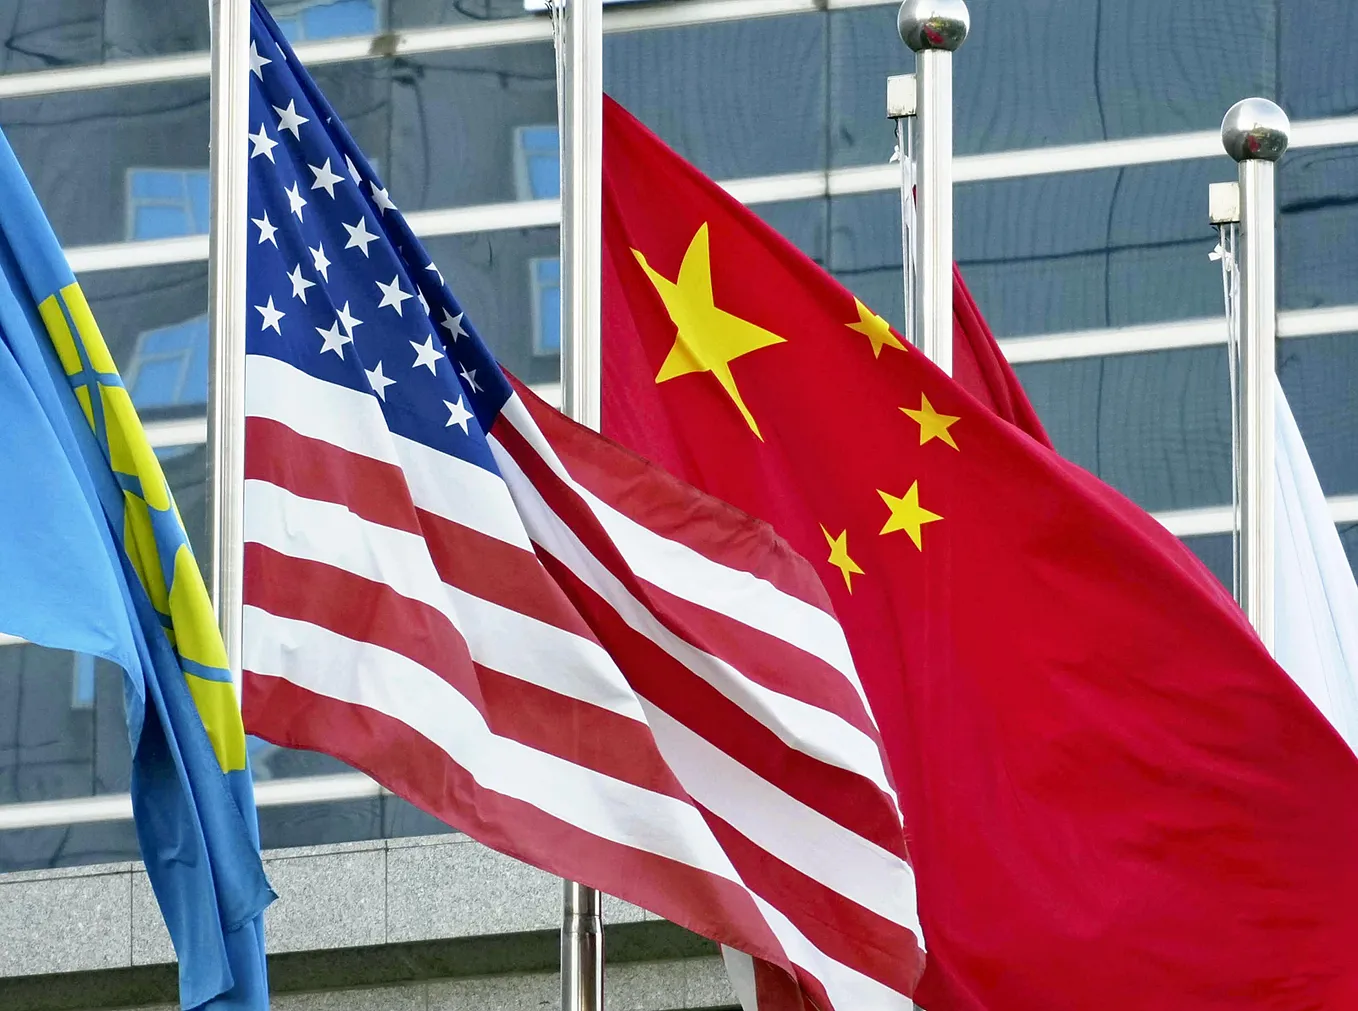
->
603;14;825;179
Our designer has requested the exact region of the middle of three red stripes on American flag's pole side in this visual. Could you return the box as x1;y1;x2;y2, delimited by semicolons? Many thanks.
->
244;544;687;799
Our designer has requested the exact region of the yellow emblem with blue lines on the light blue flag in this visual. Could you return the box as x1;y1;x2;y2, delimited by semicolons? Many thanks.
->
38;284;246;772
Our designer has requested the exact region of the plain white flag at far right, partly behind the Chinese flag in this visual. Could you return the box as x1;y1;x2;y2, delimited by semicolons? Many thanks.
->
1274;375;1358;753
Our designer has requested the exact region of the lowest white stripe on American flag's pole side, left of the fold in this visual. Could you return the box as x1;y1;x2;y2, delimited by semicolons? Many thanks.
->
243;606;739;883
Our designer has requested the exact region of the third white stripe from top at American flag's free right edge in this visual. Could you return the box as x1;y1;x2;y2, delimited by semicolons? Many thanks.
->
646;704;923;938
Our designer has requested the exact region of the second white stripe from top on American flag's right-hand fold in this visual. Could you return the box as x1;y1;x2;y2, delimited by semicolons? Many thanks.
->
490;436;895;798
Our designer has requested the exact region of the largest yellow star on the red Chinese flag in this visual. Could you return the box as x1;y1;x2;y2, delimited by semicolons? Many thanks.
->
631;221;785;439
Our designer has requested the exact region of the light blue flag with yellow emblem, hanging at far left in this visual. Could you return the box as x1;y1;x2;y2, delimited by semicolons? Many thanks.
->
0;122;273;1011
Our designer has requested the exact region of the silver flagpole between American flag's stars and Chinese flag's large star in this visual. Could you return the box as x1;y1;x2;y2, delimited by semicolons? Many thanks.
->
561;0;603;1011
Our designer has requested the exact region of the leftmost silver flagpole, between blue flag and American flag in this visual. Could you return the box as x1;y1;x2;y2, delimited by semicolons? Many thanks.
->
208;0;250;698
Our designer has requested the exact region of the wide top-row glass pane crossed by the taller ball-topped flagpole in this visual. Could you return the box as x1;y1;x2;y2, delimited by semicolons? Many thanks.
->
830;0;1271;164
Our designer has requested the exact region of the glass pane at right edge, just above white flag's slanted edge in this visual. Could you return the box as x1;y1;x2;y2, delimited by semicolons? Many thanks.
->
1278;333;1358;495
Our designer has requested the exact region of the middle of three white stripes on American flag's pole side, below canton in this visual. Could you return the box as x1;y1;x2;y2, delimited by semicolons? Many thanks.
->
246;481;645;722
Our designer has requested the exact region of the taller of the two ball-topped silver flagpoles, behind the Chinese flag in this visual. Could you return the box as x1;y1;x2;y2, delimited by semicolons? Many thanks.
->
896;0;971;375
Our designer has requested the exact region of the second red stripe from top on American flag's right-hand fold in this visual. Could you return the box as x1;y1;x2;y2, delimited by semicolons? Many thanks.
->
494;413;885;750
